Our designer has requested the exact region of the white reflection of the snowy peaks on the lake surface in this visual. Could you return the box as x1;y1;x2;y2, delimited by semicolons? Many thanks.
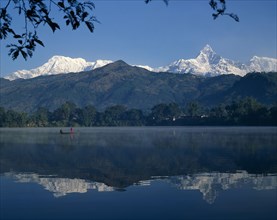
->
5;171;277;204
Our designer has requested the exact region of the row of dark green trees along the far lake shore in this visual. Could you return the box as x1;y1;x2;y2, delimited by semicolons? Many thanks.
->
0;97;277;127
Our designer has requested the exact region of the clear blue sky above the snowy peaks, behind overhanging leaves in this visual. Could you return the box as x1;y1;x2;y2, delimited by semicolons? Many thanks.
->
0;0;277;77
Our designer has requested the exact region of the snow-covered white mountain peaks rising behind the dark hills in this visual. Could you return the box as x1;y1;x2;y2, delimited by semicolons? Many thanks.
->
5;45;277;80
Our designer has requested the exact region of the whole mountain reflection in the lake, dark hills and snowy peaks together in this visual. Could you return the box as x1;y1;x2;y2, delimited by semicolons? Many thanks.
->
0;127;277;204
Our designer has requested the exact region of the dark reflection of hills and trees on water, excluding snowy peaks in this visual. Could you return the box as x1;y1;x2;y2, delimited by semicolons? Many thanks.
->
0;128;277;187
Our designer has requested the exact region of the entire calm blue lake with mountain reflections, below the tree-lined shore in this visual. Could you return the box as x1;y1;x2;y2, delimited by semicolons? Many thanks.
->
0;127;277;220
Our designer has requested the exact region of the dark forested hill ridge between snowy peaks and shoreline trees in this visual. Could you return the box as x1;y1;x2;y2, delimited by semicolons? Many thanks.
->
0;61;277;112
